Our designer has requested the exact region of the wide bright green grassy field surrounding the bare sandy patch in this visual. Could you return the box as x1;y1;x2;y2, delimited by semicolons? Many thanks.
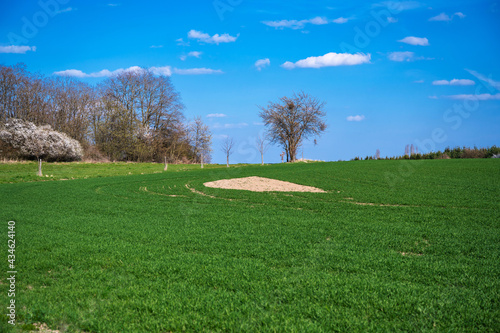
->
0;159;500;332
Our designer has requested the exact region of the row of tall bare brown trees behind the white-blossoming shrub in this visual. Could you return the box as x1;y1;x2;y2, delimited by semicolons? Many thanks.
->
0;64;211;163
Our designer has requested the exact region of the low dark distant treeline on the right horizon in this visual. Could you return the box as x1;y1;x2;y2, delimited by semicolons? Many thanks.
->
352;146;500;161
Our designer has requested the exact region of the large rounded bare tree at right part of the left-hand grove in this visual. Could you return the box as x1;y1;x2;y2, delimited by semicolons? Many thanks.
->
94;68;184;160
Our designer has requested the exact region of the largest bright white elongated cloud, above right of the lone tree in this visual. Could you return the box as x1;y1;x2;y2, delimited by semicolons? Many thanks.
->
281;52;371;69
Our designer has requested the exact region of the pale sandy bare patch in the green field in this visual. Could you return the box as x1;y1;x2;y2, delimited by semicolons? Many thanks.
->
203;177;326;193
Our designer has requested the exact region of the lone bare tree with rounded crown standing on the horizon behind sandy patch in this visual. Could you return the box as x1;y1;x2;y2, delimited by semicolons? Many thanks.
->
259;92;326;162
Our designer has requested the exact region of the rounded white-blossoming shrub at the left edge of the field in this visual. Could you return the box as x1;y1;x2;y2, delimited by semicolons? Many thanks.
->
0;119;83;161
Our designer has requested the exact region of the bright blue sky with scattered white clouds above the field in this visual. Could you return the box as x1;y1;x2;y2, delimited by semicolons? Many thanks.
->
0;0;500;163
